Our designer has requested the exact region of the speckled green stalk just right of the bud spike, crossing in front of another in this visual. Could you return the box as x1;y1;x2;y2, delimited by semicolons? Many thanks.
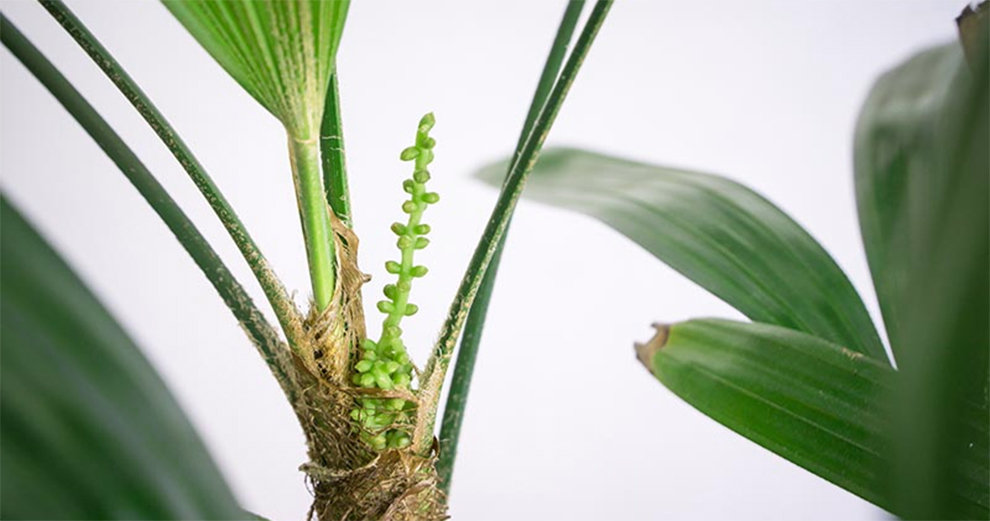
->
413;0;612;453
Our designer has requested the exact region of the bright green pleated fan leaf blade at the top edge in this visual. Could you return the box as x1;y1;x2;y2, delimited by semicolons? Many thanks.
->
162;0;350;139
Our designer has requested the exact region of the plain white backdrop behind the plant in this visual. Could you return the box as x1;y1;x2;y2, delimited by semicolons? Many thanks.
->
0;0;964;520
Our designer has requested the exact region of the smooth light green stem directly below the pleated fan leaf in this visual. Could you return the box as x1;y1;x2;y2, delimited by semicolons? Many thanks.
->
289;136;336;311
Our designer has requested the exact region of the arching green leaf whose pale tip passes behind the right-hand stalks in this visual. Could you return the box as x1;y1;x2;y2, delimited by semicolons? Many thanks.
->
478;148;887;363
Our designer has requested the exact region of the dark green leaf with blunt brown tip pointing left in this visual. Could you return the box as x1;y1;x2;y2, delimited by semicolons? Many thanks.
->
637;320;895;508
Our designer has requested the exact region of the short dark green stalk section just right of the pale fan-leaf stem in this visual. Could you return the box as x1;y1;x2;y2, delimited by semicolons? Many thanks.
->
320;71;353;227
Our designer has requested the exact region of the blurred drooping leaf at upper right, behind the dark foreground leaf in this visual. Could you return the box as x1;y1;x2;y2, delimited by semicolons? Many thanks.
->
854;45;962;358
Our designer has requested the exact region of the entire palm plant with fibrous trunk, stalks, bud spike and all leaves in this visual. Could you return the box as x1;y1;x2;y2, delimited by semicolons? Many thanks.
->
0;0;990;519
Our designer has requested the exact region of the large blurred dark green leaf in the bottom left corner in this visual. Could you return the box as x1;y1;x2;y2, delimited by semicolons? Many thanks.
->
0;197;244;519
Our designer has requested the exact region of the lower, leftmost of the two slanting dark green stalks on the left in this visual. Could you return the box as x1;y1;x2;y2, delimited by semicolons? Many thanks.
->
0;14;292;399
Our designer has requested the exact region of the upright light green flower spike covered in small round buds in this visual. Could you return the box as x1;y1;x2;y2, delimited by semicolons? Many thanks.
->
351;114;440;450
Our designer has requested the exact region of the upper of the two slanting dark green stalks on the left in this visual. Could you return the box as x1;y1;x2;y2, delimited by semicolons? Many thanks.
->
39;0;301;344
